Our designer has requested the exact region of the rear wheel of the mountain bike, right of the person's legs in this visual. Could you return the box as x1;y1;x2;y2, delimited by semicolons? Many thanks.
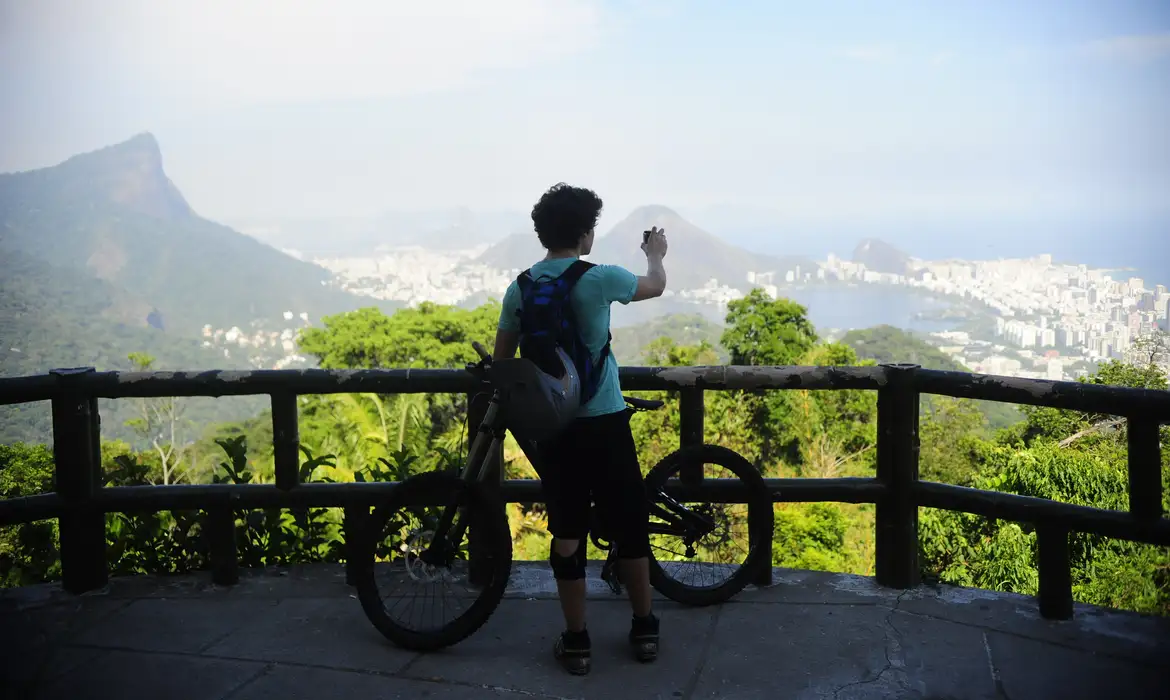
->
646;445;775;605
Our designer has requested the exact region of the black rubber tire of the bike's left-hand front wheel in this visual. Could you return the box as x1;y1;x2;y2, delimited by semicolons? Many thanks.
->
356;472;512;651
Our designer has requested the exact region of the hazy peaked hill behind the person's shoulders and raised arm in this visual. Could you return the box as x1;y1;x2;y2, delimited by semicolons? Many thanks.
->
467;206;815;291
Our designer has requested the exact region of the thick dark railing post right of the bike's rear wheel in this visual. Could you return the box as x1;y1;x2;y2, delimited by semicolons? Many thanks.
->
875;364;920;589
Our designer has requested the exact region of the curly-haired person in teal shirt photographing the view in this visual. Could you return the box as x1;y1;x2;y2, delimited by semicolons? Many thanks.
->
493;183;667;675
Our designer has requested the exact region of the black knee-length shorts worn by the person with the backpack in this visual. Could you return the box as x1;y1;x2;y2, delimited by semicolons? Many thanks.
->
537;410;651;558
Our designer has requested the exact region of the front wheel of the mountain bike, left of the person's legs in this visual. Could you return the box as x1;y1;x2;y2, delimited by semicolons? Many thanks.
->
348;472;512;651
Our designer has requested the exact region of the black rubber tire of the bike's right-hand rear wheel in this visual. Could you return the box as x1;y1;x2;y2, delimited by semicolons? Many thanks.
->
645;445;775;606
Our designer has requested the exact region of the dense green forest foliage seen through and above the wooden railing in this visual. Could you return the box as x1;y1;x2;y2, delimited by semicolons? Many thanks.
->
0;289;1170;615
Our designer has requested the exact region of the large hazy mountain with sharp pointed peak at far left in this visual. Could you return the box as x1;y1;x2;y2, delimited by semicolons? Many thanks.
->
0;133;385;334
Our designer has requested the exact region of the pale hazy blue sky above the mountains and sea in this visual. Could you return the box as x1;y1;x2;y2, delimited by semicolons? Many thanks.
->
0;0;1170;224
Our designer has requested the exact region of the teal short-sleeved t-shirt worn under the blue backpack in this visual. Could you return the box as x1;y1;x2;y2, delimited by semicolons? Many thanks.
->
500;258;638;417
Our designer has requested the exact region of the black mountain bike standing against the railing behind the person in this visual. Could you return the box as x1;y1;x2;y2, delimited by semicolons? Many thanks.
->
353;343;773;651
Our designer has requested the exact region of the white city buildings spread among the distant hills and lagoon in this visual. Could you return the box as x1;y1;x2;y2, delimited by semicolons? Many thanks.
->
194;246;1170;379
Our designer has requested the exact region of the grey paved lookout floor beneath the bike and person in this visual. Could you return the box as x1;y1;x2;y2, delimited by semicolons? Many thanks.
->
0;563;1170;700
